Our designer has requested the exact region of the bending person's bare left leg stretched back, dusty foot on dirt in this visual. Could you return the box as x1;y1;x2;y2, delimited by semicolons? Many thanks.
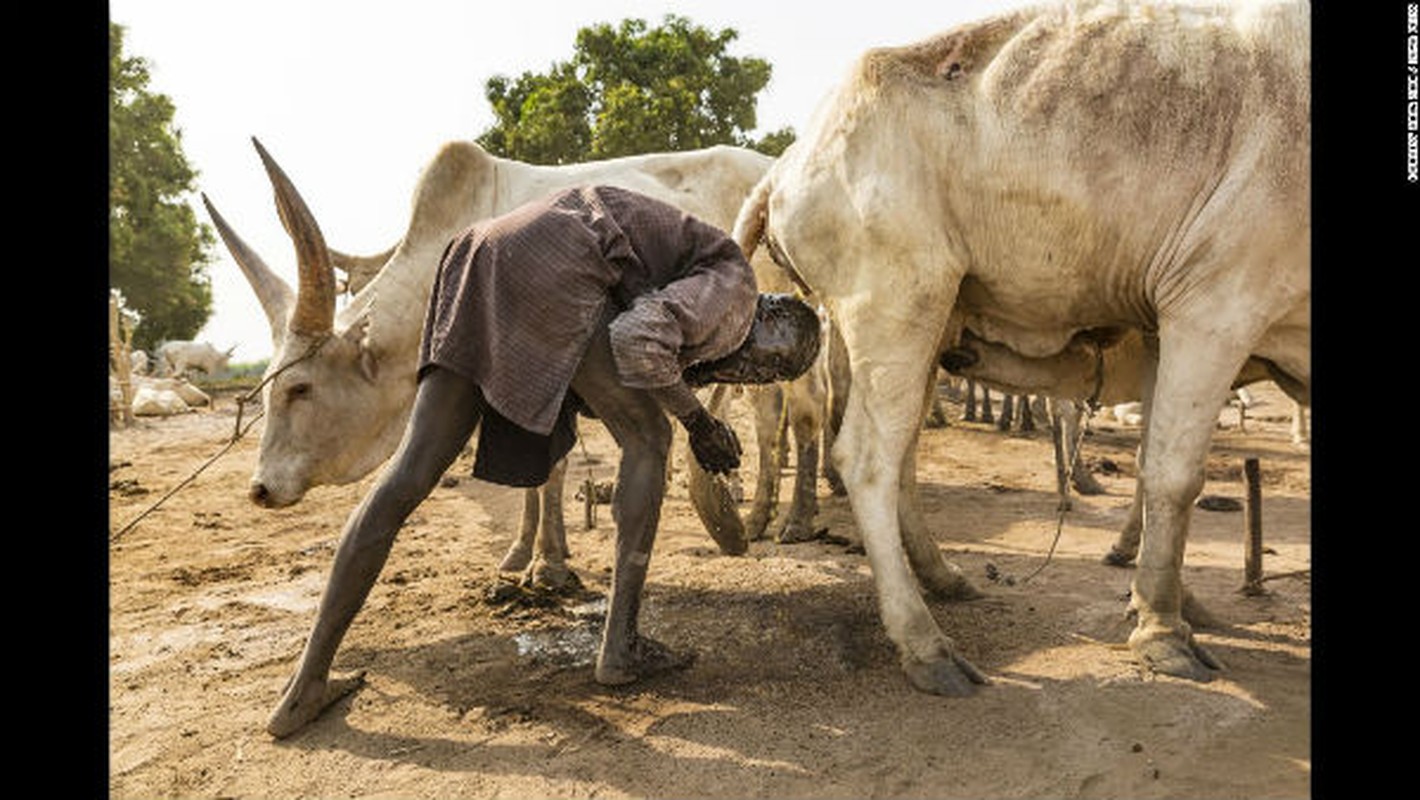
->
267;368;483;737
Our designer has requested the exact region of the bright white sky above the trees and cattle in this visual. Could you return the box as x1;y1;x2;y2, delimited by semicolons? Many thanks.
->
109;0;1020;362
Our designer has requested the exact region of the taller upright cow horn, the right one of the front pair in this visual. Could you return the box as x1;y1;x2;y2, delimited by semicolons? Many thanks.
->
251;136;335;334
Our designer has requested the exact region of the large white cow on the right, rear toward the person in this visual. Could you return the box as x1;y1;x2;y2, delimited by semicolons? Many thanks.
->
736;1;1311;695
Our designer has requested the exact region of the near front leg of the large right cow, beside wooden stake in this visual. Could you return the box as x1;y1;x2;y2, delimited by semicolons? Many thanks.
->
1129;325;1247;681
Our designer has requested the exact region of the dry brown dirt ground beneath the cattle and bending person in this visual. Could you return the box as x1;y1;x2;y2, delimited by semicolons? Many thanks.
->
108;384;1312;799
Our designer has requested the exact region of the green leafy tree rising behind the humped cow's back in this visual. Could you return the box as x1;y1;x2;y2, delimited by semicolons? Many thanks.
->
479;14;794;163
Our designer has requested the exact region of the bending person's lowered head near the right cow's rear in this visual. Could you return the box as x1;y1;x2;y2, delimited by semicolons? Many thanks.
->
684;294;821;387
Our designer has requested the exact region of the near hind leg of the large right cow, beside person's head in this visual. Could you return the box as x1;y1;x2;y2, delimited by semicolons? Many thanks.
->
834;298;985;696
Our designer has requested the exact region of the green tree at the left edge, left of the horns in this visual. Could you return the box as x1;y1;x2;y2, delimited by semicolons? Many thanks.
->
108;23;214;350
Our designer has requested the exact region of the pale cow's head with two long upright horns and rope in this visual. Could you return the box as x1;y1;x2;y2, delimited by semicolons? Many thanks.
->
203;139;413;507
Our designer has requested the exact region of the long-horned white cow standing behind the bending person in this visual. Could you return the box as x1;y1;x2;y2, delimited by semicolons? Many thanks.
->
203;142;829;574
